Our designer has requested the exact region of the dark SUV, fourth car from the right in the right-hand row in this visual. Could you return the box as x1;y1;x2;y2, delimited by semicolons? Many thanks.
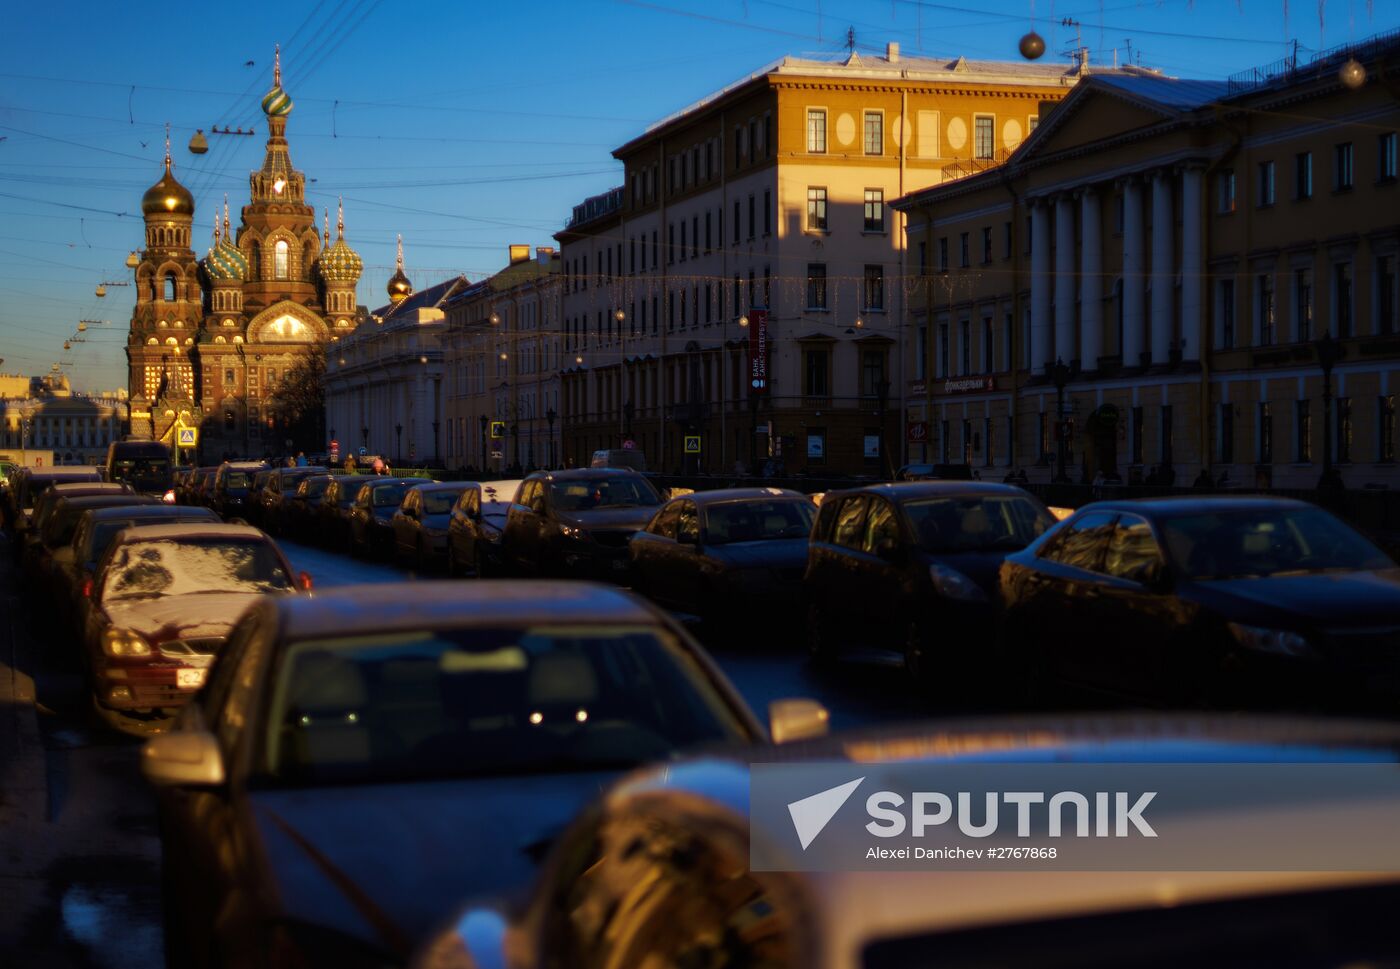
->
501;468;661;581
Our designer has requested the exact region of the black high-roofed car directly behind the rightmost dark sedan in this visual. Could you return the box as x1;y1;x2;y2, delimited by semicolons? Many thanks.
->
802;482;1054;679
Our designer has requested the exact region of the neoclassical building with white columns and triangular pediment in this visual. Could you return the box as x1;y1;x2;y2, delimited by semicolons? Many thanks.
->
893;38;1400;487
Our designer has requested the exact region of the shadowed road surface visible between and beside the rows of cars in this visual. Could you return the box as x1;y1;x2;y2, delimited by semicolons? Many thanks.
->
0;538;937;969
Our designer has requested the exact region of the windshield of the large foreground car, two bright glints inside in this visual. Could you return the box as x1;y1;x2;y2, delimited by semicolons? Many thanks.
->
260;625;748;784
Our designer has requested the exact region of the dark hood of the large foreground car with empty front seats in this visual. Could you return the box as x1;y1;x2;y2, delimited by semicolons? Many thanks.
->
249;772;619;945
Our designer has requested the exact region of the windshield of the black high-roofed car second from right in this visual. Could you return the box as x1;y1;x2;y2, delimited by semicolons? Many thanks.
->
904;494;1054;552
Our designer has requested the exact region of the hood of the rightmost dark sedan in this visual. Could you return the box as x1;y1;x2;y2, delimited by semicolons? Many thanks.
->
1190;569;1400;627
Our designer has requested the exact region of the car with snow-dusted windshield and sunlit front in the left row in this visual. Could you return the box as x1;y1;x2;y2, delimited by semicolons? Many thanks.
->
83;522;311;732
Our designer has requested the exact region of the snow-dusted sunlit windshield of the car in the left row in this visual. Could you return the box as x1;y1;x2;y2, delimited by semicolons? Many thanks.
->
102;538;291;601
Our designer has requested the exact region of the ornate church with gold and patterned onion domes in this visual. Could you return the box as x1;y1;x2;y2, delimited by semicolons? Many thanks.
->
126;55;363;463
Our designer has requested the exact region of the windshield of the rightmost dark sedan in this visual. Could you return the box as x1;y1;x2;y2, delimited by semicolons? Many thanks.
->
1159;507;1394;580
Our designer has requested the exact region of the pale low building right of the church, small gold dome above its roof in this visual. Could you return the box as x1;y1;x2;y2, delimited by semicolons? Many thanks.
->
325;238;468;466
